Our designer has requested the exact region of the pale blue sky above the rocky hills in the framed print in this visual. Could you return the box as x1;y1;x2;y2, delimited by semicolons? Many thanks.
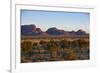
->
21;10;90;33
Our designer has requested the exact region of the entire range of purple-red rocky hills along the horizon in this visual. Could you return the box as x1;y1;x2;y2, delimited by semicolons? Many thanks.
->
21;24;88;36
